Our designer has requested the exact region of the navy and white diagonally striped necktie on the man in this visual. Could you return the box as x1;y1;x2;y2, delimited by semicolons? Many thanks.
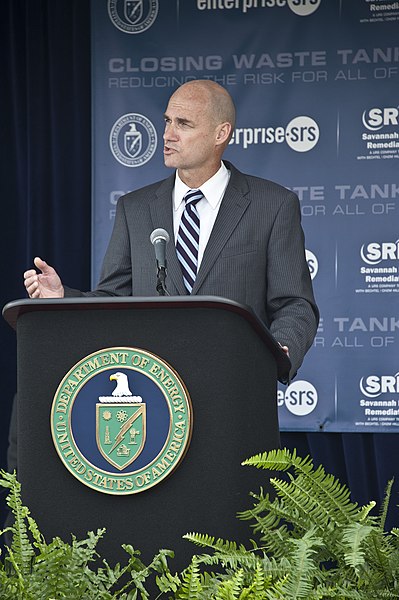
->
176;190;204;294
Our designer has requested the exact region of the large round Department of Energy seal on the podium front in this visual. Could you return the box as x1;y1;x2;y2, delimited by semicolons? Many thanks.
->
51;347;192;495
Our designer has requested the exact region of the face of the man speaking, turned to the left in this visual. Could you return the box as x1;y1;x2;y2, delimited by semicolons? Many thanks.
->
163;86;218;172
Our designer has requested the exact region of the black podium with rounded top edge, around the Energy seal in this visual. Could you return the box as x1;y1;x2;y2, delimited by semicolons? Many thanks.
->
3;296;289;570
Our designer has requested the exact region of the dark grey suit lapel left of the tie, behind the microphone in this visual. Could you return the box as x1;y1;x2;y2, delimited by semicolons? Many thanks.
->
150;175;187;295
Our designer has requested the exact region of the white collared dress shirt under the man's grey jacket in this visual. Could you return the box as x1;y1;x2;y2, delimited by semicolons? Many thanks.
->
172;163;230;268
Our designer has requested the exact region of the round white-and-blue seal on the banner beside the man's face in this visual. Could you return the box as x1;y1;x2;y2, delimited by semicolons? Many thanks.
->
109;113;158;167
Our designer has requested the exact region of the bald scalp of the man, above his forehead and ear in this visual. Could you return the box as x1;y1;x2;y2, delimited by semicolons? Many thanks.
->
172;79;236;141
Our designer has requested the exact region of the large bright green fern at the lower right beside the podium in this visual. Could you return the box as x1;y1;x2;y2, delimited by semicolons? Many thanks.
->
161;450;399;600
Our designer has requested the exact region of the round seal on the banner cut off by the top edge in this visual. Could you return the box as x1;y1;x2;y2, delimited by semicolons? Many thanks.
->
108;0;158;33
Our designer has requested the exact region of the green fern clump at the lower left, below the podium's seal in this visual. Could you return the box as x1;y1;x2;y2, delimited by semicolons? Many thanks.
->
0;471;173;600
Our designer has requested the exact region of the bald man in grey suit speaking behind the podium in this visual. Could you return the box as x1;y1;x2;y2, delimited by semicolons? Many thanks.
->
24;80;318;377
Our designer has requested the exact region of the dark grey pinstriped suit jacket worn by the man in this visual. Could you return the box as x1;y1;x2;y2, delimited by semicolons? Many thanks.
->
65;161;318;377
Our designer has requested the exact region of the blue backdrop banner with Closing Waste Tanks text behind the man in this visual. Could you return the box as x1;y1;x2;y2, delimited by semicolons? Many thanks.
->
91;0;399;432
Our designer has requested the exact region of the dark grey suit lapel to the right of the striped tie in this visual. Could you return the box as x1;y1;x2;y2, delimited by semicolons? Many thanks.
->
192;161;250;294
